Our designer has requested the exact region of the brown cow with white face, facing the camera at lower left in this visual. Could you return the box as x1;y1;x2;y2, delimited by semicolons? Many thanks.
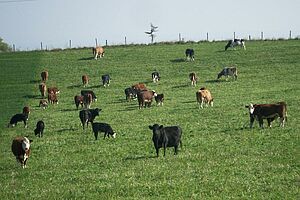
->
11;136;32;168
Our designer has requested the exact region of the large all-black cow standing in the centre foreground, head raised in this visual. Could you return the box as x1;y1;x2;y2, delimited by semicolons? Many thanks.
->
149;124;182;157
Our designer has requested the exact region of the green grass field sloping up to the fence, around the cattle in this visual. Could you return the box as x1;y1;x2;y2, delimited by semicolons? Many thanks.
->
0;40;300;199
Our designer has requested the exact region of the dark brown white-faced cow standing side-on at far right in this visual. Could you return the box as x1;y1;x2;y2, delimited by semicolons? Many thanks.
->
246;102;287;128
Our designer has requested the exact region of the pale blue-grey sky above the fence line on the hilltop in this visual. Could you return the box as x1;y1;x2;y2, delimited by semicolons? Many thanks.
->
0;0;300;50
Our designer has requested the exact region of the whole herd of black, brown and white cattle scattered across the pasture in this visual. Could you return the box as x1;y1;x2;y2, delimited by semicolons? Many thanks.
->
8;39;287;168
